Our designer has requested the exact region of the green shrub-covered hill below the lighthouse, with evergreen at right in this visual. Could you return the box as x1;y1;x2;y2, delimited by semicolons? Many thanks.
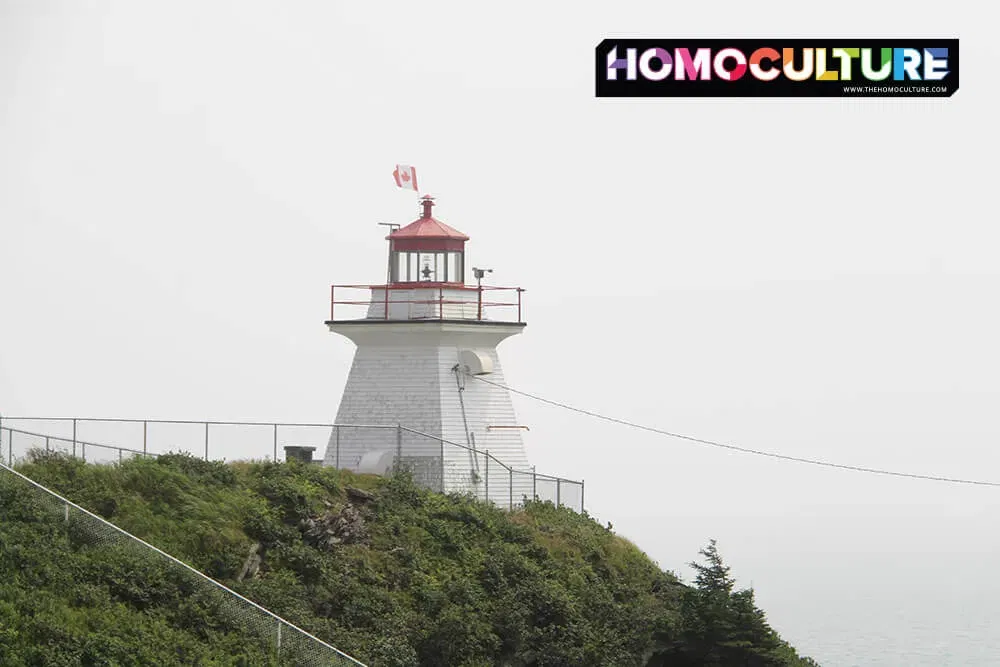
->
0;453;815;667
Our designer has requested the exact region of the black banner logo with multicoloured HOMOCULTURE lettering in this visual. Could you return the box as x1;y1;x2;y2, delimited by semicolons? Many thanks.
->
596;39;958;97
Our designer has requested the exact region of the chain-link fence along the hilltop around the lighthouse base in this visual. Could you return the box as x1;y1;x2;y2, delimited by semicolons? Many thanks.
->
0;416;585;512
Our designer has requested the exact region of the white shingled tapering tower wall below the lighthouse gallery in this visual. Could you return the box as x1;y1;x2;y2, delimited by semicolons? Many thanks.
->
324;323;532;506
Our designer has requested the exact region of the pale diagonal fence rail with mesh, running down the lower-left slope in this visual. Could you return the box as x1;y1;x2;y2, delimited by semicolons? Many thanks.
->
0;462;365;667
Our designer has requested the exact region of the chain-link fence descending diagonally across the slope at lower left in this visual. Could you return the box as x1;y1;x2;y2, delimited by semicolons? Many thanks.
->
0;460;364;667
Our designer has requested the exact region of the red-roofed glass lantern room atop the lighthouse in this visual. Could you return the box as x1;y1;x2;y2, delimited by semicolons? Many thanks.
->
386;195;469;285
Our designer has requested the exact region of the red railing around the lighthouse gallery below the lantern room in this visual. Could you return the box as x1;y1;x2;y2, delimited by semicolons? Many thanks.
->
330;283;525;323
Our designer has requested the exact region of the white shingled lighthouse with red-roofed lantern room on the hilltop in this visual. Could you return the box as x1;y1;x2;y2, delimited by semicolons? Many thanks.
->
324;196;532;504
